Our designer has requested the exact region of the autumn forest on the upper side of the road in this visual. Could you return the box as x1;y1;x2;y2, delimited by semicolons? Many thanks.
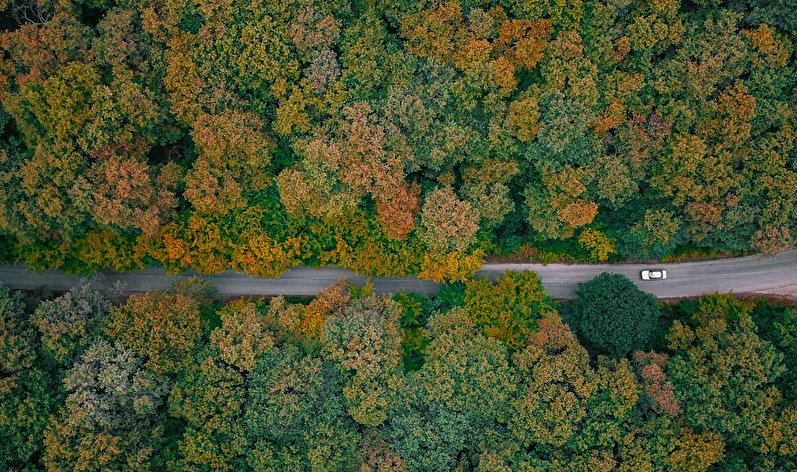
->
0;0;797;281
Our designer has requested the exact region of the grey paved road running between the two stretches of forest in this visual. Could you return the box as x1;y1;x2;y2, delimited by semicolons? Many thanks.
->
0;250;797;298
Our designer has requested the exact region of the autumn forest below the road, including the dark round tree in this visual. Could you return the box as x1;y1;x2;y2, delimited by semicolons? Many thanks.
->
0;272;797;472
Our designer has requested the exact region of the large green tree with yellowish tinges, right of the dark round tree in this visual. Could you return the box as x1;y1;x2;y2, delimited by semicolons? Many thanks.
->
667;296;784;450
